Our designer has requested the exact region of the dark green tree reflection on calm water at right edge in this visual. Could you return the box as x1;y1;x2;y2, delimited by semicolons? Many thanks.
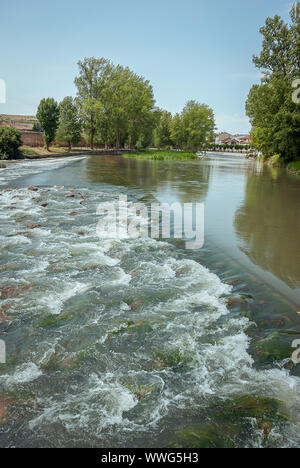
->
235;167;300;288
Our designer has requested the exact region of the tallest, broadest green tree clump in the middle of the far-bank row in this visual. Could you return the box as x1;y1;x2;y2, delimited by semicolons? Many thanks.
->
75;57;156;148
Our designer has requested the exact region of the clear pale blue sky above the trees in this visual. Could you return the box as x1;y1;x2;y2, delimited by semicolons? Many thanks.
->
0;0;292;133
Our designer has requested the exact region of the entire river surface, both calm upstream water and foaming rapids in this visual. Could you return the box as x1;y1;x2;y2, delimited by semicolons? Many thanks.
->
0;155;300;447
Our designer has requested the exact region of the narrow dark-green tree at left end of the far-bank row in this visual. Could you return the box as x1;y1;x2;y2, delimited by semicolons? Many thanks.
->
36;98;59;151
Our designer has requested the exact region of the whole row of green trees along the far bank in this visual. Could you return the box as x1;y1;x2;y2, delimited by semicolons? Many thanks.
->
37;57;215;151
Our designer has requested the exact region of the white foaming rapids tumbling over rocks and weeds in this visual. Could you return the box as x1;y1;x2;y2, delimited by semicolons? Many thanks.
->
0;156;300;447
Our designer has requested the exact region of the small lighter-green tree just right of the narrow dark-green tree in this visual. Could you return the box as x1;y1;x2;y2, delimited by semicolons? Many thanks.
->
56;96;81;150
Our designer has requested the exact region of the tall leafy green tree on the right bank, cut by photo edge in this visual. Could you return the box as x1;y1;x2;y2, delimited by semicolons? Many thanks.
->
246;2;300;161
